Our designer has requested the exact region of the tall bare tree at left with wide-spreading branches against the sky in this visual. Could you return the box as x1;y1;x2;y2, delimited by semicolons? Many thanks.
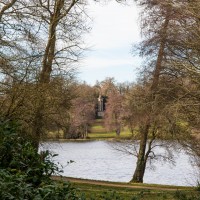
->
0;0;88;146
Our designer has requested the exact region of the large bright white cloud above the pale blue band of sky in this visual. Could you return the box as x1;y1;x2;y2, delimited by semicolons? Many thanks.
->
88;1;140;49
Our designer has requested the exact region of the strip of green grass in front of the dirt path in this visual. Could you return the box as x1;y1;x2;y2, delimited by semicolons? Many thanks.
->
70;183;200;200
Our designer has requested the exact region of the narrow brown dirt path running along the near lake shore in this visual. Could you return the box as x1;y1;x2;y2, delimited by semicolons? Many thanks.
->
52;176;193;191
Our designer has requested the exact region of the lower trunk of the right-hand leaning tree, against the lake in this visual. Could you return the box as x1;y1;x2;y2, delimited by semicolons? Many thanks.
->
130;123;150;183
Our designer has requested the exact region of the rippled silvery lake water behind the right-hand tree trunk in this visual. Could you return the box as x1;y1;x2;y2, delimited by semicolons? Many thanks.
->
41;141;197;186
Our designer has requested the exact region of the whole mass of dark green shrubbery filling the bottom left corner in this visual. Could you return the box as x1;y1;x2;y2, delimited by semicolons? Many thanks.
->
0;120;82;200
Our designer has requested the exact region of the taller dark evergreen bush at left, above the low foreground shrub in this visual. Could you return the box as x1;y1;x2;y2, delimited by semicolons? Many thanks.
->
0;121;59;186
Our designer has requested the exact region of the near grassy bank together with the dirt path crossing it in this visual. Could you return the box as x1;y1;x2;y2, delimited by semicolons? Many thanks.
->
51;178;200;200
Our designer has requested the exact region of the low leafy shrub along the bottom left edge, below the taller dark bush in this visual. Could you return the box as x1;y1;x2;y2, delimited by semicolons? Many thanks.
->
0;170;81;200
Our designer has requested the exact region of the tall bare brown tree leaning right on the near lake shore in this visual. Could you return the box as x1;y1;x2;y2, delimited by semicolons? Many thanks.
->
125;0;195;182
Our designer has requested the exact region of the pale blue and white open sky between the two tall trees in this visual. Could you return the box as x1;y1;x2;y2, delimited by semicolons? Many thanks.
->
79;1;141;85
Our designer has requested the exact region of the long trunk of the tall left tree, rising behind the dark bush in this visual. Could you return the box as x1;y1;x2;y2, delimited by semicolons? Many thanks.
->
33;0;63;148
